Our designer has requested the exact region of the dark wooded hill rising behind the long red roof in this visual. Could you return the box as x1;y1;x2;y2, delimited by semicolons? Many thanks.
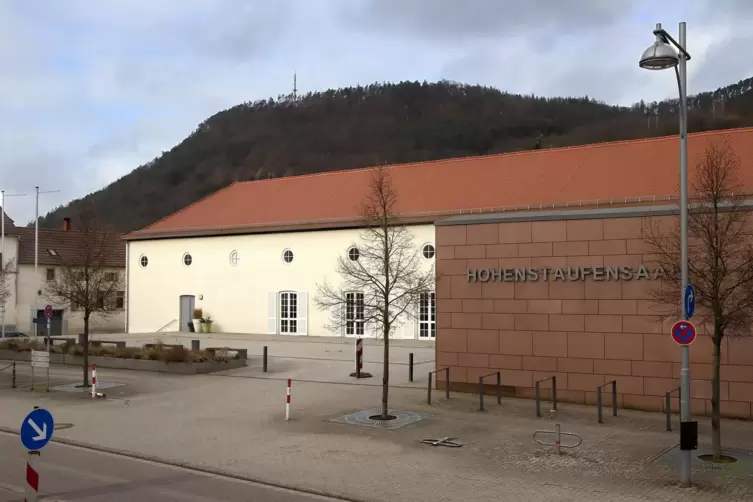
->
40;78;753;231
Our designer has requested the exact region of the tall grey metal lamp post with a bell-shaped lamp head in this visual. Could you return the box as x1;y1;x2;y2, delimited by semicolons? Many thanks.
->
638;22;691;487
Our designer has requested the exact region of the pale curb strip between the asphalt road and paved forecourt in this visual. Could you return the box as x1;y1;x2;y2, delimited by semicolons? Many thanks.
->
0;426;362;502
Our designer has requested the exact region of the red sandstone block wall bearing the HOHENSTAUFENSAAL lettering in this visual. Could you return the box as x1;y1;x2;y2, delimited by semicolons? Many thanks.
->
436;217;753;419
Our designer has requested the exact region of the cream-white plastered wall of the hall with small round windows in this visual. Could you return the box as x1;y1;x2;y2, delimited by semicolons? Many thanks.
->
127;225;434;338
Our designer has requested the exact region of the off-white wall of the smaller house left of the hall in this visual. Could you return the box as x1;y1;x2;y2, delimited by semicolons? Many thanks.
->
16;265;125;336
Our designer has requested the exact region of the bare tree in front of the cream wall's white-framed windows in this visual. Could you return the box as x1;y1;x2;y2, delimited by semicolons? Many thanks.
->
315;168;434;420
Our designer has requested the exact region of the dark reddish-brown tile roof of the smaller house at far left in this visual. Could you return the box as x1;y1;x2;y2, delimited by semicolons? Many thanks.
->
13;227;126;268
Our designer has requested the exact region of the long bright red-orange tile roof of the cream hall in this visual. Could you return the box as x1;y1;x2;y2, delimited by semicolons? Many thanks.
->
126;128;753;239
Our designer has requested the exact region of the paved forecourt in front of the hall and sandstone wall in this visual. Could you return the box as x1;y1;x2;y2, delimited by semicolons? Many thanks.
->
0;358;753;502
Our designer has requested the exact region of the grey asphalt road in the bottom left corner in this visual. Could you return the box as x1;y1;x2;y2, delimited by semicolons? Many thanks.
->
0;433;342;502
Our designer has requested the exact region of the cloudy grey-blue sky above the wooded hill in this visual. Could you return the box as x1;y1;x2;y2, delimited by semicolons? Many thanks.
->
0;0;753;224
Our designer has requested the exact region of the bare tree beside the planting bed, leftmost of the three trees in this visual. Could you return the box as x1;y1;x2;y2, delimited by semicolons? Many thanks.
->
44;208;123;387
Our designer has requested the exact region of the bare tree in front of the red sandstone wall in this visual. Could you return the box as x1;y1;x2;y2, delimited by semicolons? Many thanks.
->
647;141;753;458
